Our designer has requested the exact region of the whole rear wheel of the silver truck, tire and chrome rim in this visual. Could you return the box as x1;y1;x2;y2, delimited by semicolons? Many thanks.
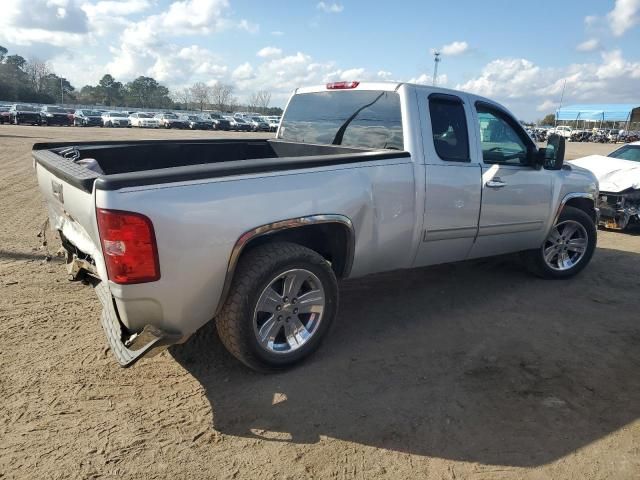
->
216;242;338;371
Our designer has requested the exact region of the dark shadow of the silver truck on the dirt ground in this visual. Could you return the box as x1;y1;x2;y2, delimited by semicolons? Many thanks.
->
171;249;640;466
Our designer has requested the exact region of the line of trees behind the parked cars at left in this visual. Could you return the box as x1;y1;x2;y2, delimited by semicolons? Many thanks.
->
0;46;282;115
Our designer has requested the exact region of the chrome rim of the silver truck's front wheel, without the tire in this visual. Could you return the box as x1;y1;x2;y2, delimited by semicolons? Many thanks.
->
542;220;589;271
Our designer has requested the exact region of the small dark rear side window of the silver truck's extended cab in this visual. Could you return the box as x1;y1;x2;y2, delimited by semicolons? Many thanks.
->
429;95;470;162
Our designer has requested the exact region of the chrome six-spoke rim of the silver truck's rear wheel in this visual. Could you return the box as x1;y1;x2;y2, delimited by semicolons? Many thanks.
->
253;268;325;354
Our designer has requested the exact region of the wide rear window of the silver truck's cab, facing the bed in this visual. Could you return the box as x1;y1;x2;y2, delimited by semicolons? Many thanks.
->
279;90;404;150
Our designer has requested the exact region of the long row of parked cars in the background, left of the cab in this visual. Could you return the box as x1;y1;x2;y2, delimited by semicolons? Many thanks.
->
0;103;280;132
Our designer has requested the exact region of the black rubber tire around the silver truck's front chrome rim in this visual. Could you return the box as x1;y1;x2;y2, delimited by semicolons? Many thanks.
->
522;206;598;280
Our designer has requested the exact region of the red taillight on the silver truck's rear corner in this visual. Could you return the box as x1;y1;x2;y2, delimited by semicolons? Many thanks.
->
97;208;160;284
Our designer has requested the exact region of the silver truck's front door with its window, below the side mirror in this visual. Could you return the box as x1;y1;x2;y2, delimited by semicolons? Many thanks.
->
470;102;552;258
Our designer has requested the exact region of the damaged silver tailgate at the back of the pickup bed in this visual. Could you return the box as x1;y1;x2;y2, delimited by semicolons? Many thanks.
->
33;150;106;272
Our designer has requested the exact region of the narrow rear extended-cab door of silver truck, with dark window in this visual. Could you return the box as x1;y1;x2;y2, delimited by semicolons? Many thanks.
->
414;89;481;266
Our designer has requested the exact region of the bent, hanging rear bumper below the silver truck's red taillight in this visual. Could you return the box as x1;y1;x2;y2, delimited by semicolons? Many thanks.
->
94;282;182;367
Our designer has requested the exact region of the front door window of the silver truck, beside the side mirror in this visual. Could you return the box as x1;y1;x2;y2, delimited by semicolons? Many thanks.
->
476;104;528;166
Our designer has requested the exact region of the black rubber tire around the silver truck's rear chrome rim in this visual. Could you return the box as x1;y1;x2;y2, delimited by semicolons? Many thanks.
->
215;242;338;372
